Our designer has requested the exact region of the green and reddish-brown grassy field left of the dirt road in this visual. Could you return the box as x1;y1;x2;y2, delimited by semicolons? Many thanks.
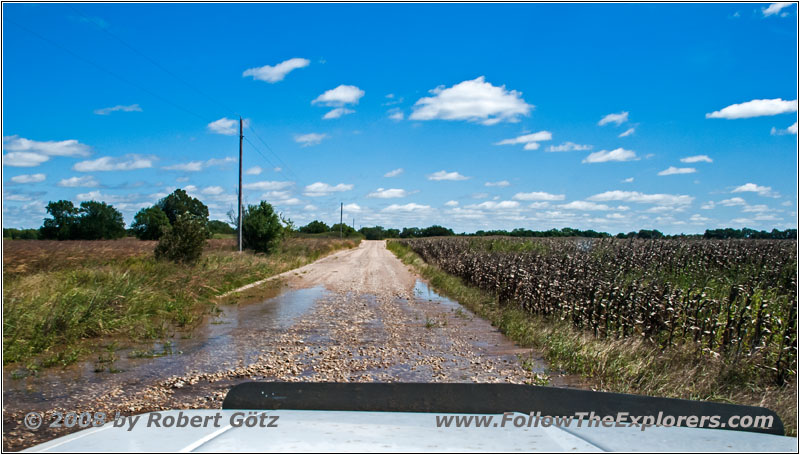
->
3;238;358;371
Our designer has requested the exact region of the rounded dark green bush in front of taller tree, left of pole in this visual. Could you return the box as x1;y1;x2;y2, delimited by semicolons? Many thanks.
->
155;213;208;264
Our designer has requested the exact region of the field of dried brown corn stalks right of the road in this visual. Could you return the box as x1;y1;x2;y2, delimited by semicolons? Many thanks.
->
402;237;797;385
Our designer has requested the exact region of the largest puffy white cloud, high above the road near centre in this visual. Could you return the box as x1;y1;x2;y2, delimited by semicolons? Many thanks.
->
409;76;533;125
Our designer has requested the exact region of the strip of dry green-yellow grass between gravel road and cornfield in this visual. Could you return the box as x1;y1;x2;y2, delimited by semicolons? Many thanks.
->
387;241;797;436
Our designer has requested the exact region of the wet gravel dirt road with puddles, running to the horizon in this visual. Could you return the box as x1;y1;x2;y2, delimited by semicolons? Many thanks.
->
3;241;563;450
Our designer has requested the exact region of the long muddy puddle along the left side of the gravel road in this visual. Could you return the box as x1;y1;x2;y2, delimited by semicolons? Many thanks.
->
3;287;328;409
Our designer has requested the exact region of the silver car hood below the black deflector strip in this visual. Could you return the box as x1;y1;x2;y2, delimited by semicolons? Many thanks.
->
26;409;798;452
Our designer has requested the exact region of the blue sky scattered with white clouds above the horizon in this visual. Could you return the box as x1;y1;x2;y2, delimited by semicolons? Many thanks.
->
3;3;798;233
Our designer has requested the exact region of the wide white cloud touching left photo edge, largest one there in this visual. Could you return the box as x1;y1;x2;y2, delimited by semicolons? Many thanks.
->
3;135;89;167
